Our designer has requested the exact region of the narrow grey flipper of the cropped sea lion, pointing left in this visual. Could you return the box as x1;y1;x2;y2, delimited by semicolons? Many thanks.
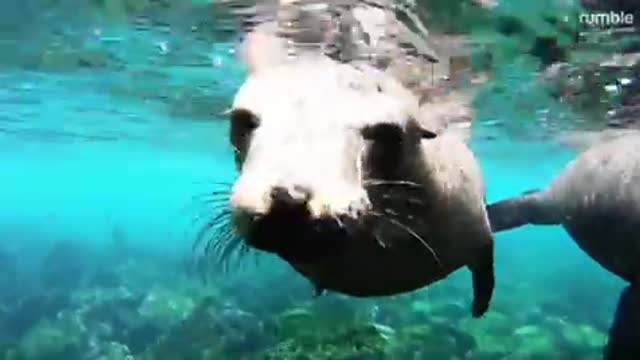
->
487;190;557;232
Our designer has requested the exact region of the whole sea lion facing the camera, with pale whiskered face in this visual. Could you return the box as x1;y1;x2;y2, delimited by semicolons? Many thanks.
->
205;53;495;317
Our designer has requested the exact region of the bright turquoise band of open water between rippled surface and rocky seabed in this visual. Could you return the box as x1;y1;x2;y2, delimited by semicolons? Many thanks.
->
0;65;621;307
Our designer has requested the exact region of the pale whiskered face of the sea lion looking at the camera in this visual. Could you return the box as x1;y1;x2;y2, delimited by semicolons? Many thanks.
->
225;58;435;262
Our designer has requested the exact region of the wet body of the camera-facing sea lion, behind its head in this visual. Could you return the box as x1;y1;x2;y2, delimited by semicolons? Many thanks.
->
292;130;493;296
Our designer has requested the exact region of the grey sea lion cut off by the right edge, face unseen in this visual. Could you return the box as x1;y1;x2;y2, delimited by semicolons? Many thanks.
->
488;134;640;359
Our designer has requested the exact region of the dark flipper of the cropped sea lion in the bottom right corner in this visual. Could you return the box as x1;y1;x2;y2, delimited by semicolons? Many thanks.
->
604;285;640;360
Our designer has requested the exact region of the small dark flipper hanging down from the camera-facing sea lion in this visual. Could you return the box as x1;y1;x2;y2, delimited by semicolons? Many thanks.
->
469;242;495;318
